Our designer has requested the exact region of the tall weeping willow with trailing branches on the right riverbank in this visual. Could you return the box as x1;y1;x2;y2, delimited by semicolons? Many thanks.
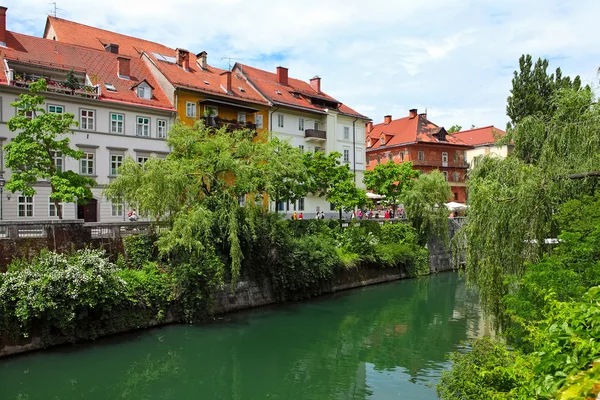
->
457;88;600;327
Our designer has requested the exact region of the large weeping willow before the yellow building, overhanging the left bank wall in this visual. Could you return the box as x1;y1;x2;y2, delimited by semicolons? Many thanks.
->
105;124;302;285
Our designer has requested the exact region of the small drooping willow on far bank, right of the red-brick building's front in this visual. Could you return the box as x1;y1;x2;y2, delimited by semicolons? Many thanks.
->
404;170;452;241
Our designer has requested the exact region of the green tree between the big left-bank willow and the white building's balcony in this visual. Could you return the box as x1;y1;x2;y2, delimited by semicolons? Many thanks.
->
257;138;308;213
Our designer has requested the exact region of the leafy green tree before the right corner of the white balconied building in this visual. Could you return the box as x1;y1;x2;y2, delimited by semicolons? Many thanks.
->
303;152;367;220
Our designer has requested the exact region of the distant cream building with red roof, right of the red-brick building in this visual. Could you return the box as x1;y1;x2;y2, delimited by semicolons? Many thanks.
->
452;126;514;168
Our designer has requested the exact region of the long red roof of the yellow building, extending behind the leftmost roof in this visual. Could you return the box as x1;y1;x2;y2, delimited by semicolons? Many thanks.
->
46;17;268;105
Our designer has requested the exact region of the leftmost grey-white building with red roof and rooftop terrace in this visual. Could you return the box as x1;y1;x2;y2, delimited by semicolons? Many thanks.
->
0;8;175;222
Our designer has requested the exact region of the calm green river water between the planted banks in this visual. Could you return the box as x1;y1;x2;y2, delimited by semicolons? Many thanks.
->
0;273;485;400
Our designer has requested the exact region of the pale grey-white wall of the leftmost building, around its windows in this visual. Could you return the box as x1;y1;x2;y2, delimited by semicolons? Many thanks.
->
0;90;174;222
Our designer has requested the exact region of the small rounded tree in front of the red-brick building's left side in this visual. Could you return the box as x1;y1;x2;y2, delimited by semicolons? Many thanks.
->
363;160;419;210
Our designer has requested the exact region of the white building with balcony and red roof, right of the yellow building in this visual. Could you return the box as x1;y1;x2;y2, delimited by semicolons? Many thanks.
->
233;63;369;218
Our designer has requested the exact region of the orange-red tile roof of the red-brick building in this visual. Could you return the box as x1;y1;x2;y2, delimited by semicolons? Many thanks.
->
367;114;470;151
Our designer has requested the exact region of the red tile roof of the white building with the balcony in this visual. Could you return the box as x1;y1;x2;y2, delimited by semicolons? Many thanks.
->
234;63;369;119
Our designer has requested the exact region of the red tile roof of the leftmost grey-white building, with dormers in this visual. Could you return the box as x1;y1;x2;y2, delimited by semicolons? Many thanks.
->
0;32;174;111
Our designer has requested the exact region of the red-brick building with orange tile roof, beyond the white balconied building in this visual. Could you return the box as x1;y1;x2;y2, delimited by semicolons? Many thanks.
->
366;109;472;203
